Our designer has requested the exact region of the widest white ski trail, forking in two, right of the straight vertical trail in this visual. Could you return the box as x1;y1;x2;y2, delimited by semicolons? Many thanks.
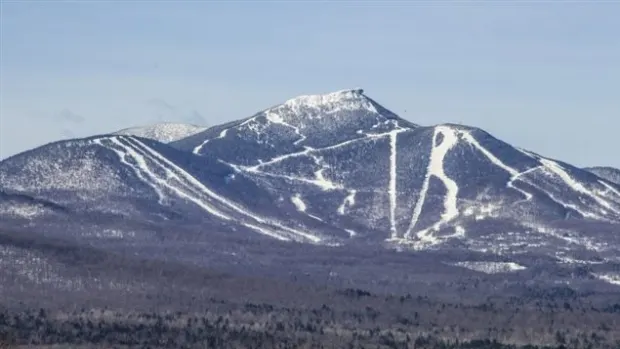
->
404;126;459;238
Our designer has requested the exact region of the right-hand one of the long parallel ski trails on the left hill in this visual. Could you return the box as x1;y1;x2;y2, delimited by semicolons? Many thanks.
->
131;139;321;243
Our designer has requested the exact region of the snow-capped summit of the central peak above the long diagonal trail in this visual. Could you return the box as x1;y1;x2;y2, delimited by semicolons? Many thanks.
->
175;89;419;160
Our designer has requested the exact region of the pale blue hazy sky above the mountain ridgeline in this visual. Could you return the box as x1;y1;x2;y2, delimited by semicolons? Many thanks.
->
0;1;620;167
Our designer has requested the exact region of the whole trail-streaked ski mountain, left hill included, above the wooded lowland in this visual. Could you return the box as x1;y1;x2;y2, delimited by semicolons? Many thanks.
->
0;89;620;288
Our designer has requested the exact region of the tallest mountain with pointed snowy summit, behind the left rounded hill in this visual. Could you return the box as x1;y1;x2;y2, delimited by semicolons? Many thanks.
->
172;90;620;252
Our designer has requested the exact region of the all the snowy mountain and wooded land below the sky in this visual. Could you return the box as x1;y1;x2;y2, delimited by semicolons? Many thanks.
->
0;89;620;348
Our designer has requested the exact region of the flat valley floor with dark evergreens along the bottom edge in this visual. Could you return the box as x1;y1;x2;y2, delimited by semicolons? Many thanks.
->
0;290;620;349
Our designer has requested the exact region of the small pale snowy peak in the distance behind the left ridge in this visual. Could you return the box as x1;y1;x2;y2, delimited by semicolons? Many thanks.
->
113;123;207;143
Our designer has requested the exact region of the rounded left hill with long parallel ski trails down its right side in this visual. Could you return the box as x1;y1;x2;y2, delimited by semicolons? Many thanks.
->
0;136;342;242
